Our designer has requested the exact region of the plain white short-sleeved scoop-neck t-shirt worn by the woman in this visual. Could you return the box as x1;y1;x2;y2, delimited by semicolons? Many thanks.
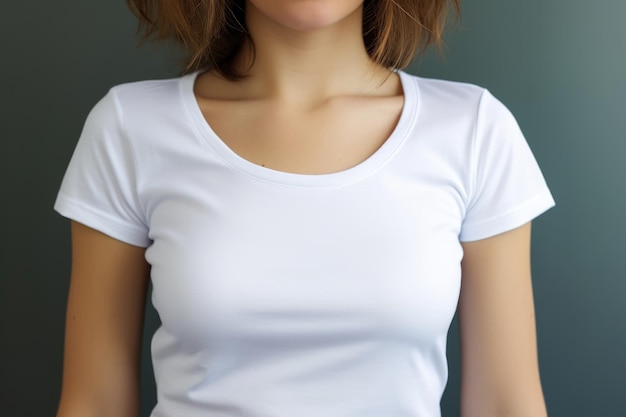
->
55;72;554;417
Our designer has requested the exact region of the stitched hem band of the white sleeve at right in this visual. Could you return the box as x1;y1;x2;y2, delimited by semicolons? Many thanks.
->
459;191;555;242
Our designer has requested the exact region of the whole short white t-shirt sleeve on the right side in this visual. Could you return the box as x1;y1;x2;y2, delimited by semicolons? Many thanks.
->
459;91;554;242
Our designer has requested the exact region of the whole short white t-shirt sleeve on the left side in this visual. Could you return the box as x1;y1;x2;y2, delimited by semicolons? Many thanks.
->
54;90;150;247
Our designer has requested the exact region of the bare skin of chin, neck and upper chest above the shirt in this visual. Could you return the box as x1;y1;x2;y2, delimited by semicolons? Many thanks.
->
195;0;403;174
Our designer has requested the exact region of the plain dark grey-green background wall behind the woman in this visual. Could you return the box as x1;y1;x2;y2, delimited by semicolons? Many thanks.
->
0;0;626;417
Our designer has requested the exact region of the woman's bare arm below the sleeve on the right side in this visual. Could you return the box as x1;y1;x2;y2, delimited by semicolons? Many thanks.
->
459;223;547;417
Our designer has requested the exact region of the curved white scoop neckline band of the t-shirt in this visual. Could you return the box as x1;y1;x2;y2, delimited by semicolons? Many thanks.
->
179;71;419;187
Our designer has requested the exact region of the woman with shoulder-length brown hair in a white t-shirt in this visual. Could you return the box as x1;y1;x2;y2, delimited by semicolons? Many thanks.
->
55;0;553;417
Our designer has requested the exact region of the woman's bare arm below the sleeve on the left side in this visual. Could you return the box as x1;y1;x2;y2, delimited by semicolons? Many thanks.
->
57;222;149;417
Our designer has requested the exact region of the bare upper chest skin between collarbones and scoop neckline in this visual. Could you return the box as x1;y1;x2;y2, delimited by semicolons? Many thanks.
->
195;70;404;174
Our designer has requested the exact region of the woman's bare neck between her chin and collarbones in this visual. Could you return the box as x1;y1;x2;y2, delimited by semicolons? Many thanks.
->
230;2;389;107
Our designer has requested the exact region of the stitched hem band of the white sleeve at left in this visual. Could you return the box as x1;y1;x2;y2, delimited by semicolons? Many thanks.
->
54;195;151;248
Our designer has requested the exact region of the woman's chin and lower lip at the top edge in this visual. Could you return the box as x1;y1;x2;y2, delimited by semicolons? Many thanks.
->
246;0;363;32
